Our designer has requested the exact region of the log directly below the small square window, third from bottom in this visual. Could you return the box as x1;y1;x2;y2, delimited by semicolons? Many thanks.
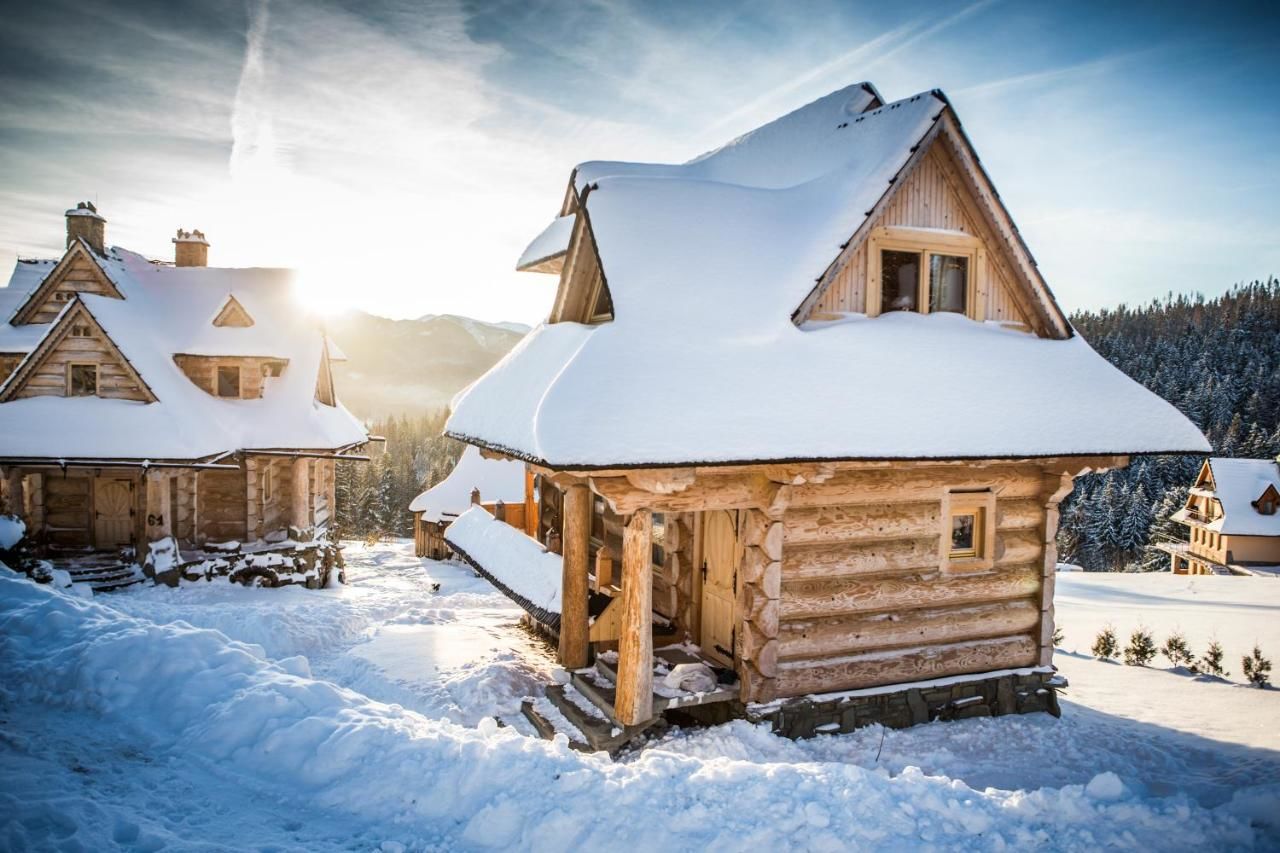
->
782;565;1042;620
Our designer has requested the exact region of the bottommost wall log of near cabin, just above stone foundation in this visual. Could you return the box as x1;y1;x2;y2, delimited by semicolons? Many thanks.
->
776;634;1038;695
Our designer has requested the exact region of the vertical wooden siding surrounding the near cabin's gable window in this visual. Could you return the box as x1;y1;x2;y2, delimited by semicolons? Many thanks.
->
813;142;1027;324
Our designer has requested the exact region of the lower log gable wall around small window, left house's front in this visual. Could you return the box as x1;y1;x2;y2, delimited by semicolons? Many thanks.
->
0;300;156;402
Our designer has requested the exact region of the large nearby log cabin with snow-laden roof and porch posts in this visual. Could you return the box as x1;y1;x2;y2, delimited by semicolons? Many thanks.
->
447;83;1207;734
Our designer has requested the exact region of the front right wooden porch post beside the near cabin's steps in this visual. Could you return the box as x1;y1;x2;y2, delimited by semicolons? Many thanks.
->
613;510;653;726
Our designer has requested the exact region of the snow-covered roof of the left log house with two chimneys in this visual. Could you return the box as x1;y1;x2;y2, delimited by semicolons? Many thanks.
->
0;248;366;460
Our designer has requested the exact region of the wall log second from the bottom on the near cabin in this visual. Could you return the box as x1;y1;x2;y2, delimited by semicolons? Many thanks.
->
778;598;1041;660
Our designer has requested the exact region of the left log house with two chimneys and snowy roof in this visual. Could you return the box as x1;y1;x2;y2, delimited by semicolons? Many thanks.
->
0;202;369;584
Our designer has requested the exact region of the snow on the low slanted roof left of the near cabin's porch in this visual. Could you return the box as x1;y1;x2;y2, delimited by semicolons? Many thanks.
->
444;506;562;613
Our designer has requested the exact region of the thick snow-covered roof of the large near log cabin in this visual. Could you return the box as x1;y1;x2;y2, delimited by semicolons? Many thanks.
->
448;85;1208;467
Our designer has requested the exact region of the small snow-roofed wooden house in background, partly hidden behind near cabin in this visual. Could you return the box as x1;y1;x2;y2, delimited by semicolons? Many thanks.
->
408;447;538;560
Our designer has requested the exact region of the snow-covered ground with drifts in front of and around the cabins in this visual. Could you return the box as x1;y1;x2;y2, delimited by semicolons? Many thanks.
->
0;543;1280;850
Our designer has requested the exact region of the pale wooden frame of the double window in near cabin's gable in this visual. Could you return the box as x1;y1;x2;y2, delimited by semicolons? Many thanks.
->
867;225;987;323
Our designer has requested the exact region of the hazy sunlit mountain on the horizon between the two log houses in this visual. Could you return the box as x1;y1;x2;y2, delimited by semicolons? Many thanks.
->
326;311;529;420
